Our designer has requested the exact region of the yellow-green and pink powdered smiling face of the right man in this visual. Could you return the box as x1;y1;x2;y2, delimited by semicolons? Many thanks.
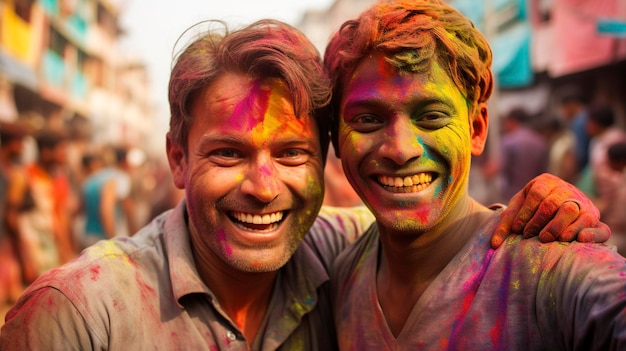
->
338;54;487;234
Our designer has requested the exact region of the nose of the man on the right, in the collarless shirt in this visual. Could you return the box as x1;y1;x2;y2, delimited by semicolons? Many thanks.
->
379;116;424;166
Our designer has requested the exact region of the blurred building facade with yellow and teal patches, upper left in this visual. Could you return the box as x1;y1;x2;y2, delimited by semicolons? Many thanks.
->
0;0;154;154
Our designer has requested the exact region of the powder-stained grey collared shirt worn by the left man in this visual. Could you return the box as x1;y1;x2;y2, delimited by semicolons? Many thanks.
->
0;201;373;350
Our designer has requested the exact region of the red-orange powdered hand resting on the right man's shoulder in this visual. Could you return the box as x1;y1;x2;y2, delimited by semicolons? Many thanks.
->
491;173;611;248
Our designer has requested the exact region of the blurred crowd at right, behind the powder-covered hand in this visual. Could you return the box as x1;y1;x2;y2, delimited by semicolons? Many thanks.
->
470;88;626;255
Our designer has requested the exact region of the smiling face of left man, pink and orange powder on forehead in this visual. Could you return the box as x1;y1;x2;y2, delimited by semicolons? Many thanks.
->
167;73;324;272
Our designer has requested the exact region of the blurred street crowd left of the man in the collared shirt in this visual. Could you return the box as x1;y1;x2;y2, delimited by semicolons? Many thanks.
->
0;122;182;314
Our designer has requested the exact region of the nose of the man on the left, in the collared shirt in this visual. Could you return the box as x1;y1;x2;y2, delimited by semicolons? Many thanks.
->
241;156;282;204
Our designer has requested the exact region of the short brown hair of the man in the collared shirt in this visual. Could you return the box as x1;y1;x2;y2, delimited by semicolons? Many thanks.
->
169;20;331;155
